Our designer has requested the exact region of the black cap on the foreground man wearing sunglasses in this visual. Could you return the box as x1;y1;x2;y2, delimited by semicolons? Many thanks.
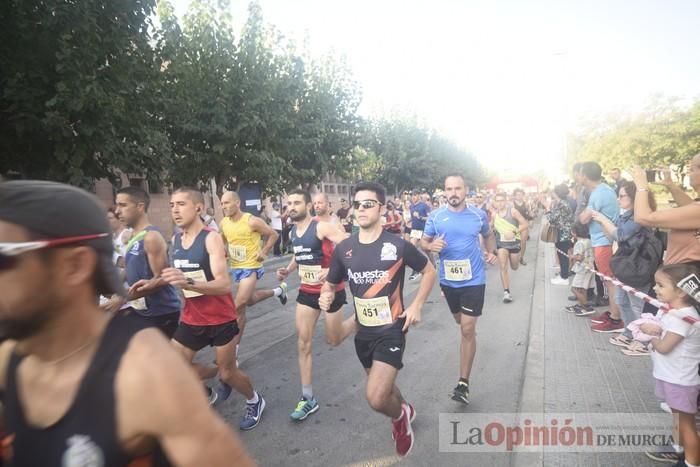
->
0;180;124;295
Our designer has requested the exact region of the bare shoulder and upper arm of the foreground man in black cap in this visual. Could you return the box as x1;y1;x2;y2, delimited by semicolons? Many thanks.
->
115;330;254;467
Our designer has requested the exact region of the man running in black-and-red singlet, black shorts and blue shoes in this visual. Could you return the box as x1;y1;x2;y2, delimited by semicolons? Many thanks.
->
162;188;265;430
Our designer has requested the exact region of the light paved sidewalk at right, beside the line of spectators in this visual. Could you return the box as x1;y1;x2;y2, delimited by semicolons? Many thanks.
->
513;243;672;467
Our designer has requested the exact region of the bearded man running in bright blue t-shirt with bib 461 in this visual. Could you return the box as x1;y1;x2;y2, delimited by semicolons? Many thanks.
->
421;175;498;404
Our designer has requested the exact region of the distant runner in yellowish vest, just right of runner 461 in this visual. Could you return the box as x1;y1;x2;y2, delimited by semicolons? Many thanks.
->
492;193;527;303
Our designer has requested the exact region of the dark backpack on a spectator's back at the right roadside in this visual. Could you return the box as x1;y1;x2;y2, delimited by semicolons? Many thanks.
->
610;227;664;287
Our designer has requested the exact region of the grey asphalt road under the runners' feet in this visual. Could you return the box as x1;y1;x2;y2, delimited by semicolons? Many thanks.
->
198;240;537;466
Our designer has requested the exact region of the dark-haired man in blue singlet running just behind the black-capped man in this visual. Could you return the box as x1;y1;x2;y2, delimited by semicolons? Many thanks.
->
115;186;182;339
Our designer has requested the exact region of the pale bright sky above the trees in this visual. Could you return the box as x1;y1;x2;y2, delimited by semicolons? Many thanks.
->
174;0;700;178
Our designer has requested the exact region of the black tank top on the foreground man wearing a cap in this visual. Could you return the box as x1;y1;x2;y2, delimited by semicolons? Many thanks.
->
2;316;170;467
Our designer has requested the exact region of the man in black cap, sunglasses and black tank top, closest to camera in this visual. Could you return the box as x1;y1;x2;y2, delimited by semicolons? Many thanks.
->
0;181;252;467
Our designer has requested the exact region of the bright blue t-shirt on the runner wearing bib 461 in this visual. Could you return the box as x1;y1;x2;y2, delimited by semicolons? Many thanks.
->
423;205;491;288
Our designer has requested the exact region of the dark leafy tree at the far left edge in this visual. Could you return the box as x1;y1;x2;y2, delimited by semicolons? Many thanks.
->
0;0;170;187
